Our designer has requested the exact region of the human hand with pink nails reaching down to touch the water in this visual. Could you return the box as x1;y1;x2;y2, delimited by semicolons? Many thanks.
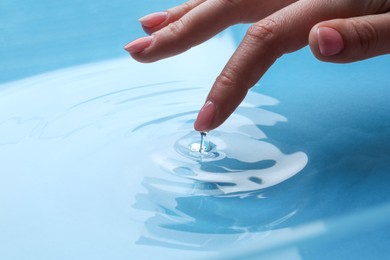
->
125;0;390;131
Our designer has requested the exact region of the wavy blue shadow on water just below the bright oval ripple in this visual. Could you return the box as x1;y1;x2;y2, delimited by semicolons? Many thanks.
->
133;178;300;251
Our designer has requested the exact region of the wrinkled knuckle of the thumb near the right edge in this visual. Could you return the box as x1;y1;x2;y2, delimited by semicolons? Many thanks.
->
351;18;379;54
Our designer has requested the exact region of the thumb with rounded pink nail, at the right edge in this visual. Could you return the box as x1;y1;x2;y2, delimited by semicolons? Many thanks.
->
309;13;390;63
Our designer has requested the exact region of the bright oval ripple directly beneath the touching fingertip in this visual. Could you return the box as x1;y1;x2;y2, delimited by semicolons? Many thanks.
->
153;128;307;196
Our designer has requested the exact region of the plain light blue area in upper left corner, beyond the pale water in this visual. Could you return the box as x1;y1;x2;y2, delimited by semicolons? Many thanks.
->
0;0;184;83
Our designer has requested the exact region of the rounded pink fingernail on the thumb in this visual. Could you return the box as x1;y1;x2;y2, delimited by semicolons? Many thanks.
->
317;27;344;57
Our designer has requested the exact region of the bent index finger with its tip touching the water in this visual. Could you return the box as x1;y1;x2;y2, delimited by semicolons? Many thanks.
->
194;0;363;131
